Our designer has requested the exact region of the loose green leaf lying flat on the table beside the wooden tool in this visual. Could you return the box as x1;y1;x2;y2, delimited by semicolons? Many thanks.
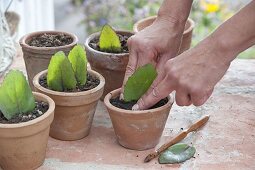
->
158;143;196;164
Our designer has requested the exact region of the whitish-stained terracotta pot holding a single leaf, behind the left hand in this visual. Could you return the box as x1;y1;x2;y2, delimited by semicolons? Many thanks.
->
85;30;133;100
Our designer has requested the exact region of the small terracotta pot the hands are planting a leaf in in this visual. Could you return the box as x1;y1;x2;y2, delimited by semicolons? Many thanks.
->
104;89;173;150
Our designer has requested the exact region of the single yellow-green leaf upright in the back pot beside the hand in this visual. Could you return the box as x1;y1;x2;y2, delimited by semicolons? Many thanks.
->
99;24;121;52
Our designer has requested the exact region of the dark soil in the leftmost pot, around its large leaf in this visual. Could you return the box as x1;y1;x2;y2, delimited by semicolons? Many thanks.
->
0;101;49;124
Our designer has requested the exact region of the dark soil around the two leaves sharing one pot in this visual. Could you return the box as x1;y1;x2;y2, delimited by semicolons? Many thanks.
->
39;74;100;92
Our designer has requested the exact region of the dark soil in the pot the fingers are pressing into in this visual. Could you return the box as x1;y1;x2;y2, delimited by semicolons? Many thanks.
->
110;97;168;110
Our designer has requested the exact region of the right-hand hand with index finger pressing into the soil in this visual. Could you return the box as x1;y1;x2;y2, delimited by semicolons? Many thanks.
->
133;38;234;110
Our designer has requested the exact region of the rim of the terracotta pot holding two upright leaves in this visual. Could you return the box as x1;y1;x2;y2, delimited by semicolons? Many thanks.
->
33;70;105;97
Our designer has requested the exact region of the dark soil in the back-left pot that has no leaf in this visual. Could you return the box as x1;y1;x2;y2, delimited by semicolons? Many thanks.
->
28;33;73;47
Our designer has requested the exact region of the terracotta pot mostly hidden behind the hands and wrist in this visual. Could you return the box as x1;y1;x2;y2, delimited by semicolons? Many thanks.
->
133;16;195;54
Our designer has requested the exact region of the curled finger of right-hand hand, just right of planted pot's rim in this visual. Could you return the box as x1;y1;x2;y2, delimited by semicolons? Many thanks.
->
175;89;192;106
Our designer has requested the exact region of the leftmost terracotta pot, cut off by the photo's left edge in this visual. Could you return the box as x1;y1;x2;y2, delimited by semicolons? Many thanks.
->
0;92;55;170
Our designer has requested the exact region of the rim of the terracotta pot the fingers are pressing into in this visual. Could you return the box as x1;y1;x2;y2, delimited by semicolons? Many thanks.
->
104;88;174;115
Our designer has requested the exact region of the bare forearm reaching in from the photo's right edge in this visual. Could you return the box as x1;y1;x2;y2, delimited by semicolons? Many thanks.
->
209;0;255;62
